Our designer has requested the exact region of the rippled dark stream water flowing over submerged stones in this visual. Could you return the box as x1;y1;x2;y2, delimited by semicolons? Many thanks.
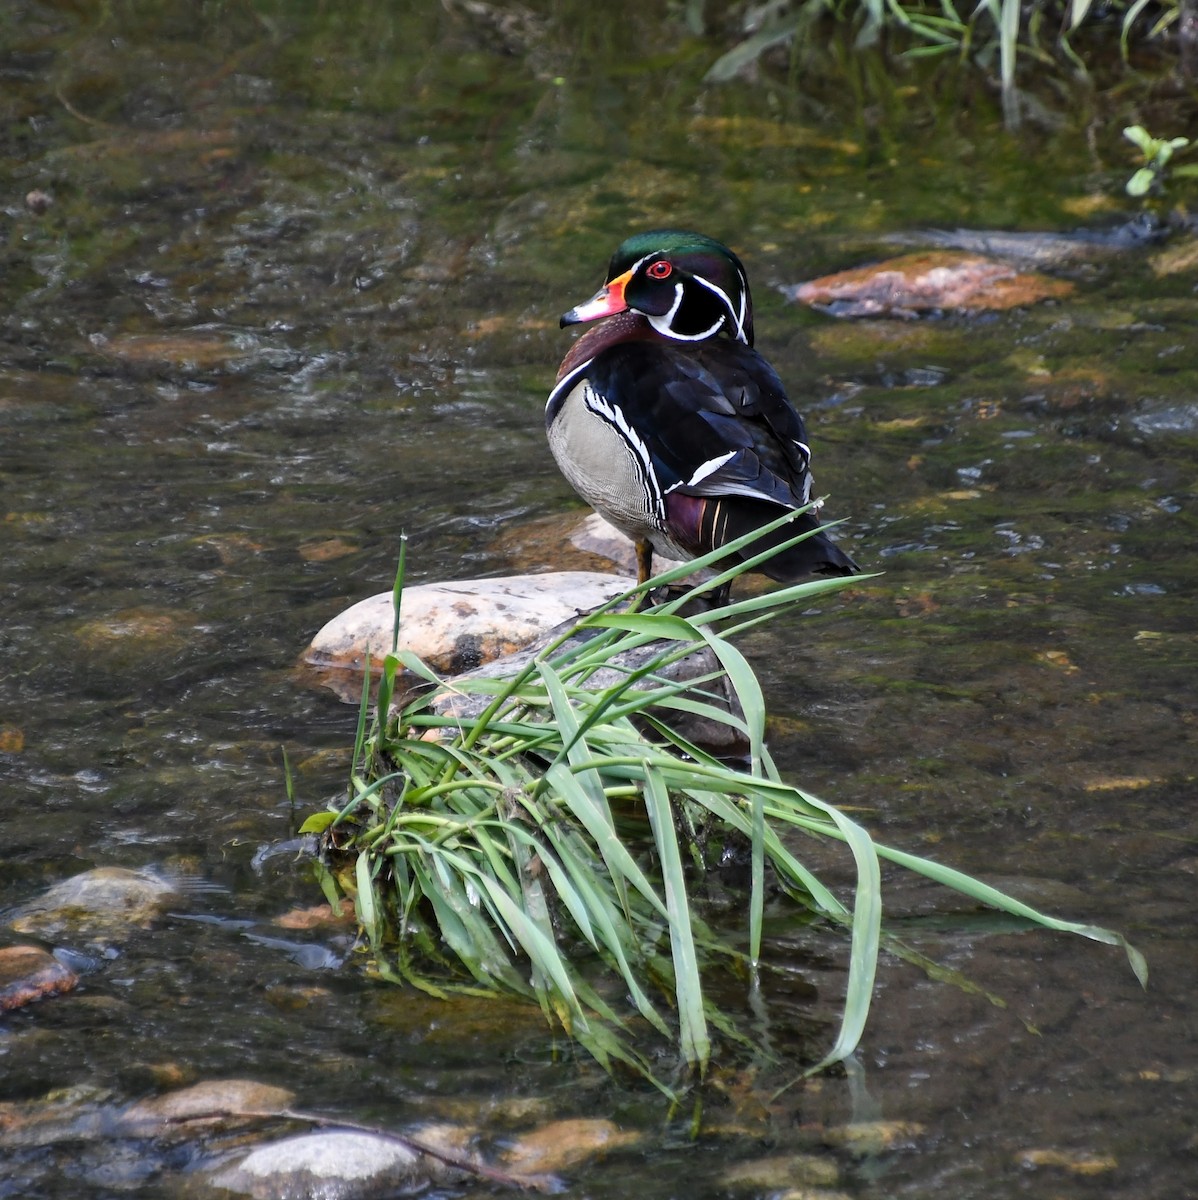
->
0;0;1198;1200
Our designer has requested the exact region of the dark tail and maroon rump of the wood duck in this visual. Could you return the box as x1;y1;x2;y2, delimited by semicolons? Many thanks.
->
667;492;861;583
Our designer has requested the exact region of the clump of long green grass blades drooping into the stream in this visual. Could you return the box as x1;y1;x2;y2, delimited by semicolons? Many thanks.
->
305;511;1145;1090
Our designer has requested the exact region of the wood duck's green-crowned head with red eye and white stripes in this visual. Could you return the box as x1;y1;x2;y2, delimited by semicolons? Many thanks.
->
562;229;753;346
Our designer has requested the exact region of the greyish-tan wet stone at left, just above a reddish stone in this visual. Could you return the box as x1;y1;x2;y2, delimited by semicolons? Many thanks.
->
10;866;178;944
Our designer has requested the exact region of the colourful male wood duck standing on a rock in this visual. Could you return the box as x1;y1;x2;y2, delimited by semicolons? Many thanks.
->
545;229;858;583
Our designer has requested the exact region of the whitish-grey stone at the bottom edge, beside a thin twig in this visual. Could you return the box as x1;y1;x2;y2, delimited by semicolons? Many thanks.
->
211;1130;460;1200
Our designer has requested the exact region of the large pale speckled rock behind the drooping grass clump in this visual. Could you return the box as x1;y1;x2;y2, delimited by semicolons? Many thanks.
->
304;571;634;674
